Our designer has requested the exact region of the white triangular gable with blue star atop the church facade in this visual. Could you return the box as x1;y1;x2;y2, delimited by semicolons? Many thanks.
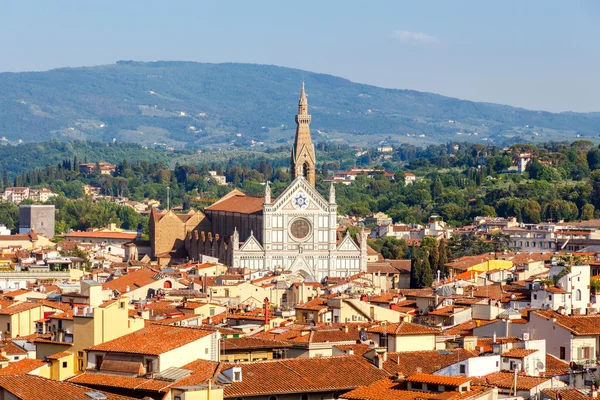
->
272;176;329;211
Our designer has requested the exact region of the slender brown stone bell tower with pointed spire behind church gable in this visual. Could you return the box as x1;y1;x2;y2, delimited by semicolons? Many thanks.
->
291;82;316;187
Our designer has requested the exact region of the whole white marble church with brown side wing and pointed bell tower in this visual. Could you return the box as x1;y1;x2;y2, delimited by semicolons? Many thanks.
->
151;84;367;280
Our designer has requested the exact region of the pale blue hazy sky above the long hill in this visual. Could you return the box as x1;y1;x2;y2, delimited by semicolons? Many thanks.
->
0;0;600;111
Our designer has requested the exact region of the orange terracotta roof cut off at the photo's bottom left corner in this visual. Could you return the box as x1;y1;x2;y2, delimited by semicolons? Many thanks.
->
0;375;133;400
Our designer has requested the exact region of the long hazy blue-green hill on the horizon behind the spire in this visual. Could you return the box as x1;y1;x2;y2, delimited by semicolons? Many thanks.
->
0;61;600;150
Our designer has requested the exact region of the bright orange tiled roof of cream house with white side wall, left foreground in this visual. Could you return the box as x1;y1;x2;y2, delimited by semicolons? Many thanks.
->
88;324;213;355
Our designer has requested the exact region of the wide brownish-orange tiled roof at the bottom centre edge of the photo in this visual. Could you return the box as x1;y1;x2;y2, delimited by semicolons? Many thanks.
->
220;355;386;398
